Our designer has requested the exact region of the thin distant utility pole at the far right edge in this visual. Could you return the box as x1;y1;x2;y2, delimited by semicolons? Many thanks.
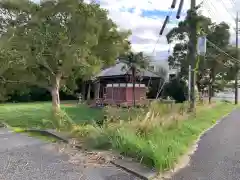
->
235;12;239;104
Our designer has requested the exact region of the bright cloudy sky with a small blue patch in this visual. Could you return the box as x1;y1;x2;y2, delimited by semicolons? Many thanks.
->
88;0;240;61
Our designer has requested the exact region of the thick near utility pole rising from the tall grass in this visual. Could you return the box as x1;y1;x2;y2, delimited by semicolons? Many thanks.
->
189;0;197;112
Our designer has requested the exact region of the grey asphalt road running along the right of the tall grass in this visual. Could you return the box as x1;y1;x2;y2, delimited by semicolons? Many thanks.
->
168;110;240;180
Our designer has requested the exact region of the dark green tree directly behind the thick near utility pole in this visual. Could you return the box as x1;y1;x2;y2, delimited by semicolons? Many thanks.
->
167;13;230;101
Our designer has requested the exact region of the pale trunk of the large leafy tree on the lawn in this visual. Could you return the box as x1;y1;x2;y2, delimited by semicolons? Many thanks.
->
51;75;61;115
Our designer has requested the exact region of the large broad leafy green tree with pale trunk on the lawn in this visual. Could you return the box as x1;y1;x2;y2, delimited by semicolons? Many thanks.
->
0;0;129;112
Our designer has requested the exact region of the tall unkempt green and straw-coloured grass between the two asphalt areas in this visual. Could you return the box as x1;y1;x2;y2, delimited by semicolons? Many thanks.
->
74;102;234;171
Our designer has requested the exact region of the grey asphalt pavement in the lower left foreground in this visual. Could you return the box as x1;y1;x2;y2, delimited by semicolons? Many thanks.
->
0;129;137;180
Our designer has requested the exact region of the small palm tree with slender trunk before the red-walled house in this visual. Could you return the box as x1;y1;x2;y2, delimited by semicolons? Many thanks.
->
120;52;150;107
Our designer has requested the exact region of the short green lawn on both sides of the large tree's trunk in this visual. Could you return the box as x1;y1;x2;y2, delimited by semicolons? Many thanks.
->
0;102;104;128
